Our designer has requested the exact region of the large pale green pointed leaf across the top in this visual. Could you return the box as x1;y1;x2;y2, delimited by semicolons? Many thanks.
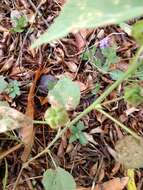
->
32;0;143;48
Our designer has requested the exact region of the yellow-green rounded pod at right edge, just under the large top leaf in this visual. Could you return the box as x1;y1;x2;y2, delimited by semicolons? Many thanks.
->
132;20;143;45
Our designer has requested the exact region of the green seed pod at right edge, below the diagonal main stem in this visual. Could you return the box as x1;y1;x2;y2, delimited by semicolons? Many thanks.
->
124;85;143;106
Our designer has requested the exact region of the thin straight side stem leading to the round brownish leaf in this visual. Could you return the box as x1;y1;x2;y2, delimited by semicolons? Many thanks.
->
95;107;140;140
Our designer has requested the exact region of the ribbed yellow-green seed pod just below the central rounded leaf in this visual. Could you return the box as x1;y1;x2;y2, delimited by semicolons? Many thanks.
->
44;107;69;129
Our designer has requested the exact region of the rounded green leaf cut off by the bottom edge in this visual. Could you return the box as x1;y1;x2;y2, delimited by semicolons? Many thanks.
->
42;167;76;190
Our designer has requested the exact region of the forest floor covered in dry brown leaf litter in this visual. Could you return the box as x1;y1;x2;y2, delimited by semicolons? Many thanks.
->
0;0;143;190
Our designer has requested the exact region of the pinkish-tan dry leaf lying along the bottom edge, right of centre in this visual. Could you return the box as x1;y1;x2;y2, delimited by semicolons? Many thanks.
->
76;177;129;190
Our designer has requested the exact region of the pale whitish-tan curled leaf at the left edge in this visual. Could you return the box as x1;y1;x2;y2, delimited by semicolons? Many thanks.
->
0;106;33;133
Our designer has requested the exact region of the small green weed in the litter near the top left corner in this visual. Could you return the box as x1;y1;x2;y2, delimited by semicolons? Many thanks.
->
11;15;27;33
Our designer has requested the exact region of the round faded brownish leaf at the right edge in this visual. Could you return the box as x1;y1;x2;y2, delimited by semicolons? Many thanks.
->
115;136;143;168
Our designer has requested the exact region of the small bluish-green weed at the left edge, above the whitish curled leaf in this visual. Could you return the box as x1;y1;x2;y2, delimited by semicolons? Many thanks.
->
0;76;20;98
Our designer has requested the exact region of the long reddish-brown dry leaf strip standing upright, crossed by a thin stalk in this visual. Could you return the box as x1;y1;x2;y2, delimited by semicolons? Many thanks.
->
20;67;43;162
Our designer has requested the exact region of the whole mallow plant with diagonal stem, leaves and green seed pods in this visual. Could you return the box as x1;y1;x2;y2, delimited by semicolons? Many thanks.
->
11;0;143;190
